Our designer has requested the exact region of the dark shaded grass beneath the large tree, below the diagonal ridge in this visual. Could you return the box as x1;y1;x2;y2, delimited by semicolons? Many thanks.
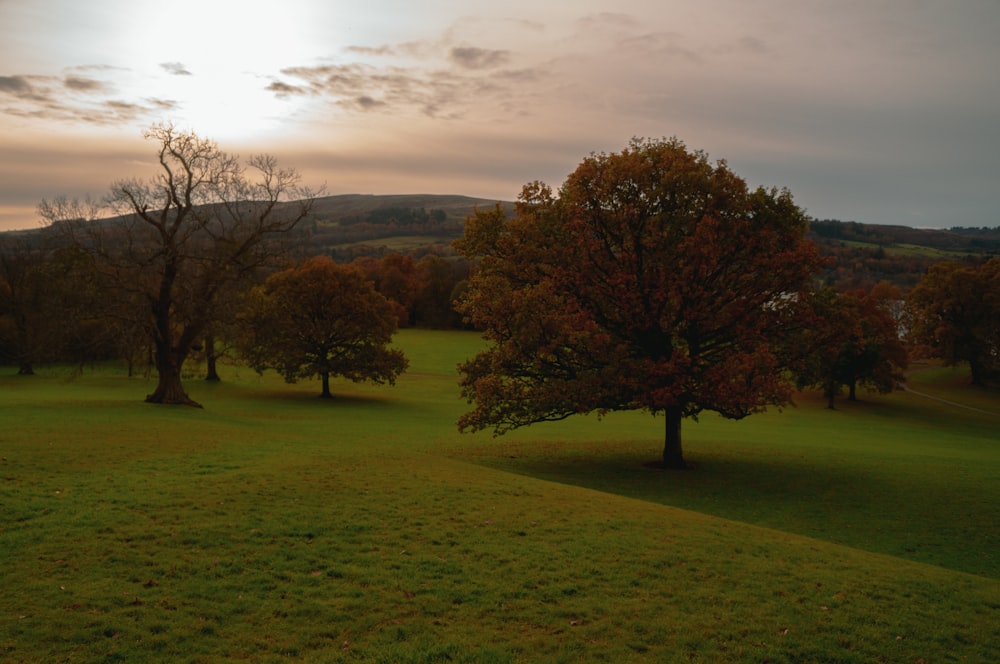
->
466;434;1000;578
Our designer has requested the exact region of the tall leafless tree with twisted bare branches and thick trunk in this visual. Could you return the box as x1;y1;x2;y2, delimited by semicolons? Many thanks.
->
39;124;314;406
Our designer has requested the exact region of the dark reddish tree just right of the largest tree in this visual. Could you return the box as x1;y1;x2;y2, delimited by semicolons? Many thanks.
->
794;282;907;408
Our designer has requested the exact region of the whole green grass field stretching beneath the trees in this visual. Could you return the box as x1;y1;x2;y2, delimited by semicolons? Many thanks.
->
0;330;1000;662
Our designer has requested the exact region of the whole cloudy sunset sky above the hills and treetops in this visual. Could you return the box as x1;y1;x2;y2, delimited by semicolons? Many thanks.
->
0;0;1000;229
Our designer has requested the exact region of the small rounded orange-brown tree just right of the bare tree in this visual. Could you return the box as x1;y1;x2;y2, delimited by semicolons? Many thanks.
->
236;256;407;398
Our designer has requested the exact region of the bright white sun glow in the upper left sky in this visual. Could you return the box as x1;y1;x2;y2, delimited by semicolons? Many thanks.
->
107;0;337;141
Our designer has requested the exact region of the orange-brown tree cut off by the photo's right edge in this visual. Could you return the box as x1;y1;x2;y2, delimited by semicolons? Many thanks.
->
906;258;1000;386
